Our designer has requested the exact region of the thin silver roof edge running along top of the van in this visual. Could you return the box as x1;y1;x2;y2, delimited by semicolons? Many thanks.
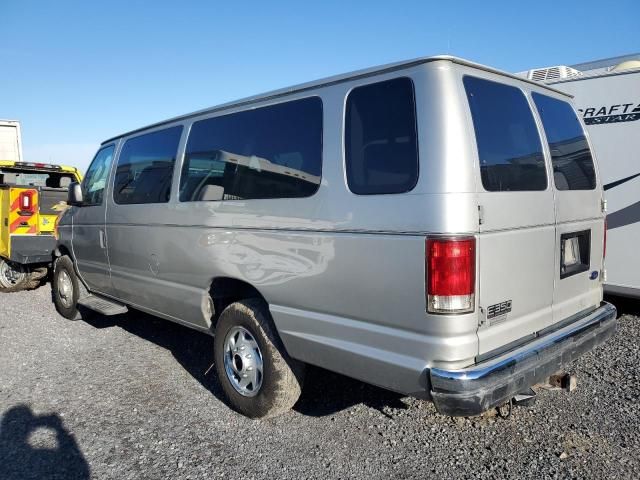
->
102;55;573;145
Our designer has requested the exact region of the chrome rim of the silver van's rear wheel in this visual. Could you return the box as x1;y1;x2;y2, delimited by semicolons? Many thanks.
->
224;327;263;397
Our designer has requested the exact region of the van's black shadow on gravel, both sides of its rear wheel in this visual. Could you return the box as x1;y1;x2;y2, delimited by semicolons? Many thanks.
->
81;307;407;417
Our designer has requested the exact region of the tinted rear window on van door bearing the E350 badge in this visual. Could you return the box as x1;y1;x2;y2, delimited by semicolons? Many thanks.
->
463;76;547;192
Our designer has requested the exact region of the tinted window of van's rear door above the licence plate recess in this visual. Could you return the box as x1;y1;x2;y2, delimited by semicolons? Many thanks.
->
532;93;596;190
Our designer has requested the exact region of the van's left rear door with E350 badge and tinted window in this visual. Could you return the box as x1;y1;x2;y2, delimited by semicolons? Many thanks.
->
463;76;556;355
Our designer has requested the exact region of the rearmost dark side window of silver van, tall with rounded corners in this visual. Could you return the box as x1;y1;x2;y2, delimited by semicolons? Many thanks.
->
344;77;418;195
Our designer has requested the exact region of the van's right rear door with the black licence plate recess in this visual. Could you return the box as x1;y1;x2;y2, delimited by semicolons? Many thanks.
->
532;92;604;323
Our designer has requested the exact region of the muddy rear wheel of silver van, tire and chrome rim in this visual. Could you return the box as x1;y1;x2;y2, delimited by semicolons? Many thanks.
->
214;299;305;418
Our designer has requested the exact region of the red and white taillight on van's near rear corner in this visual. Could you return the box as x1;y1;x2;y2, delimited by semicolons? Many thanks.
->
425;237;476;313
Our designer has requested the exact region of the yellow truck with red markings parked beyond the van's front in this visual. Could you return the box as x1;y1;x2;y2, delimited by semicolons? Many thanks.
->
0;160;81;292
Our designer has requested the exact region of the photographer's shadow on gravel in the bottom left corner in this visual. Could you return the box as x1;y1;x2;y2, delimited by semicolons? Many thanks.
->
0;405;90;480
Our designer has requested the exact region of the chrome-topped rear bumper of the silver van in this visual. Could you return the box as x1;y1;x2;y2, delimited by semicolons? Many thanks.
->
428;302;617;417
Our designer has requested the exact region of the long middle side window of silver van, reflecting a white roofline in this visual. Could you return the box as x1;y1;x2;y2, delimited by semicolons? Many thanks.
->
180;97;322;202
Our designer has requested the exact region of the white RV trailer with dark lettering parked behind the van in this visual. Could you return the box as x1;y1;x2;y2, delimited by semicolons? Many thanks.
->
522;53;640;298
